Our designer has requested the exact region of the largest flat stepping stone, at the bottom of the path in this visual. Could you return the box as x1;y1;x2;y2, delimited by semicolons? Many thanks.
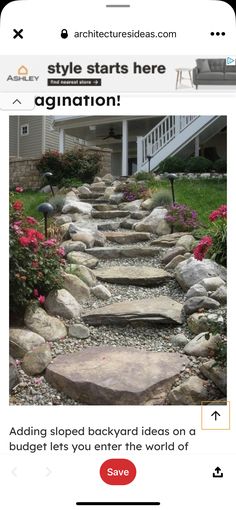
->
45;347;188;405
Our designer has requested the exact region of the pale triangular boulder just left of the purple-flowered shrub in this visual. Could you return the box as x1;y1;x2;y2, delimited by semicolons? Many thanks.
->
134;207;171;235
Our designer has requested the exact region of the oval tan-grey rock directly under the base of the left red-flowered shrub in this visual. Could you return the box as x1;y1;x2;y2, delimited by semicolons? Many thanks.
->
24;305;67;342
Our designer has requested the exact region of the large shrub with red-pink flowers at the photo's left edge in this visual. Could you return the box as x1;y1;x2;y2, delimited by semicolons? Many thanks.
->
10;200;64;312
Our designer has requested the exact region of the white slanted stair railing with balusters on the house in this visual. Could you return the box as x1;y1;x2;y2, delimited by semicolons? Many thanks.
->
138;115;198;165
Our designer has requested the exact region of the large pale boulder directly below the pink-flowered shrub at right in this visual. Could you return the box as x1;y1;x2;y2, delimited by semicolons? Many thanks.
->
175;257;226;290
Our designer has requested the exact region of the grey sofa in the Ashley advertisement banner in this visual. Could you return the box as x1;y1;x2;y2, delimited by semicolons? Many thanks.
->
193;58;236;89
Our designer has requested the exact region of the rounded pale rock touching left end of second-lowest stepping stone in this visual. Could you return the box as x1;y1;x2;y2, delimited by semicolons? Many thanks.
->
45;289;81;319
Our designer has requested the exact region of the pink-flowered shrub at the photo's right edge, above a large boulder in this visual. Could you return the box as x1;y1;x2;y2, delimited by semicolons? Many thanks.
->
193;204;227;265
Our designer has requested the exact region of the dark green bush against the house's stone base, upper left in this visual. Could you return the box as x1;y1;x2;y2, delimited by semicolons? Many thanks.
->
37;149;101;185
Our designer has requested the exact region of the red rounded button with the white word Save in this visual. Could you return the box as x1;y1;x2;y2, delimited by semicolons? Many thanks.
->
100;459;136;485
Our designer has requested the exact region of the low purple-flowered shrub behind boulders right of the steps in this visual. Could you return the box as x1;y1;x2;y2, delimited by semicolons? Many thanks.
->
165;204;199;232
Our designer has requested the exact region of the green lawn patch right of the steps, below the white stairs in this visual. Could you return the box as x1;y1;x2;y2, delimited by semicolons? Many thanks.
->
152;179;227;225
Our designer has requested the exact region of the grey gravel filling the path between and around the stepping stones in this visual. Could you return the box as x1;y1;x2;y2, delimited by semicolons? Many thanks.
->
10;215;226;405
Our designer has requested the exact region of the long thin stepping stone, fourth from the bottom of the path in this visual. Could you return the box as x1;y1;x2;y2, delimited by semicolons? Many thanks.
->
85;246;160;258
